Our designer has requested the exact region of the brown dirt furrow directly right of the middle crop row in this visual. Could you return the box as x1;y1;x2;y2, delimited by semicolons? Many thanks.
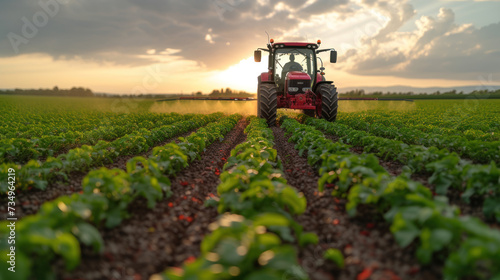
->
273;128;442;280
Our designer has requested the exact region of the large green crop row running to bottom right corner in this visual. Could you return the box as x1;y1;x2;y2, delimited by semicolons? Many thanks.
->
282;119;500;279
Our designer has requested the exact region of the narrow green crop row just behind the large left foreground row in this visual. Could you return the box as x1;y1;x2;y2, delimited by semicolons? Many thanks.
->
0;113;219;194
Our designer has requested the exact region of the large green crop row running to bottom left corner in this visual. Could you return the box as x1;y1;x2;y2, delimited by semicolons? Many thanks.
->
0;115;241;279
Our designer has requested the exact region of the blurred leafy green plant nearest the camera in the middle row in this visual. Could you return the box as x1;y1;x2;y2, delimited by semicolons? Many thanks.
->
163;214;308;280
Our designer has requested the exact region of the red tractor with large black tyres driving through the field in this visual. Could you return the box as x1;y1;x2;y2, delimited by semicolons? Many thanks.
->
254;39;338;126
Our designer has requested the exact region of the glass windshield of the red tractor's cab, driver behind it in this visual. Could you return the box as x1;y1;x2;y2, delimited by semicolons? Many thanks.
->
275;48;316;86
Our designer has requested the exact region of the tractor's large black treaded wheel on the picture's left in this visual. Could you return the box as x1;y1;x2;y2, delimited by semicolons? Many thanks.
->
257;83;278;127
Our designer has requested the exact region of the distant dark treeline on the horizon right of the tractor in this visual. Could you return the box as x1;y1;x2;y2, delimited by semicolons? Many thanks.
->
340;89;500;99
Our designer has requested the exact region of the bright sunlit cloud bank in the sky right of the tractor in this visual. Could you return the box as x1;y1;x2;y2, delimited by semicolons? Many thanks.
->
341;1;500;80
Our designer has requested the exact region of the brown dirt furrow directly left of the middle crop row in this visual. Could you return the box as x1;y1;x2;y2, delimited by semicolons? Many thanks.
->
58;120;247;280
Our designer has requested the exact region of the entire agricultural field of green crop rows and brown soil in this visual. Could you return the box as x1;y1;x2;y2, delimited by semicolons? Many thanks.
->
0;96;500;280
